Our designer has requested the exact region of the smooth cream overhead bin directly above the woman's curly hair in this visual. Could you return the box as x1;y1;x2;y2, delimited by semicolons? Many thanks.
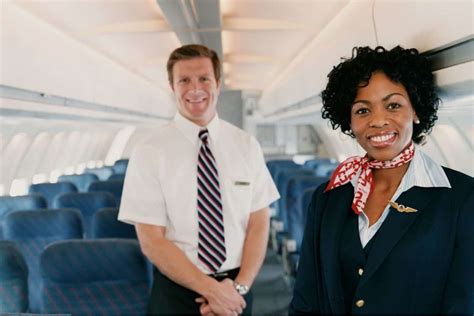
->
259;1;473;120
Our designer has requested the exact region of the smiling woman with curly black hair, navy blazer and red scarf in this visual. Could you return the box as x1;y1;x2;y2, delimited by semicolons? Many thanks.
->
290;47;474;314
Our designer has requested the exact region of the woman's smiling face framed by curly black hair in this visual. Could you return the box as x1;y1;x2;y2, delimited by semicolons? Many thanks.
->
351;72;418;160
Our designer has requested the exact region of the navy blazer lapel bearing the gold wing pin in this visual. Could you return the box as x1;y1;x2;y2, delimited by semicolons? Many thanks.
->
359;187;431;286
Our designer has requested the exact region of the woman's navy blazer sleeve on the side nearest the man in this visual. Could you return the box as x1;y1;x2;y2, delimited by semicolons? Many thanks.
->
289;184;325;315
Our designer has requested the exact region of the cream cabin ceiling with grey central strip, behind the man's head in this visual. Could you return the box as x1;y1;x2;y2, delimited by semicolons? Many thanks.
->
16;0;348;91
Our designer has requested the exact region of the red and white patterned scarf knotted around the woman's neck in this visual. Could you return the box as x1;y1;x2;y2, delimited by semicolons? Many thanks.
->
324;143;415;215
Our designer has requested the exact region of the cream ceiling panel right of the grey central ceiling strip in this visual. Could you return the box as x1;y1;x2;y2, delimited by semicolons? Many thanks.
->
220;0;348;90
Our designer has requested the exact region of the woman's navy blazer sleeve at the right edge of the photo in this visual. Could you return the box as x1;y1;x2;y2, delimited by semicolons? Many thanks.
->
441;182;474;315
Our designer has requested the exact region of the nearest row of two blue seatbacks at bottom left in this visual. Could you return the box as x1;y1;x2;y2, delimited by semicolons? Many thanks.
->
0;239;150;315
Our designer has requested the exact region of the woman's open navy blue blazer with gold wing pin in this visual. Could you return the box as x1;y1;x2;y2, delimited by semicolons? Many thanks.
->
290;168;474;315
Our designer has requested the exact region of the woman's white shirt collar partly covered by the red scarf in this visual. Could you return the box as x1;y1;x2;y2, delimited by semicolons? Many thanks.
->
351;147;451;192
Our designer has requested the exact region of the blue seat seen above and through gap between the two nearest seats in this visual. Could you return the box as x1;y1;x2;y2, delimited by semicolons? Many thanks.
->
4;209;82;313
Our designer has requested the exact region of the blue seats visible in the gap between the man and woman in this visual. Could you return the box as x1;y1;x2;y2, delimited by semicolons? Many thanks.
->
267;158;338;275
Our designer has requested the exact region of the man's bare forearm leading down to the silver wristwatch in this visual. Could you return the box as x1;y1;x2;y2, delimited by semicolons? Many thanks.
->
235;208;270;286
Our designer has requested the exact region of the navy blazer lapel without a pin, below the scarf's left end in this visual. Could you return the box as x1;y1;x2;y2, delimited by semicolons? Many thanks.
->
319;184;354;314
